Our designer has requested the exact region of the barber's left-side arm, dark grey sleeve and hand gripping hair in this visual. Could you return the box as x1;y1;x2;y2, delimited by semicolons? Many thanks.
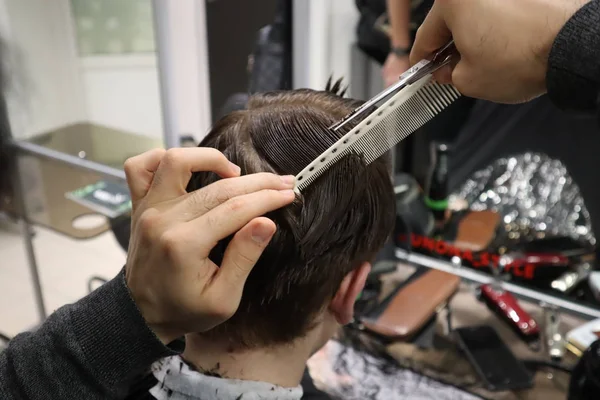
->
0;148;294;400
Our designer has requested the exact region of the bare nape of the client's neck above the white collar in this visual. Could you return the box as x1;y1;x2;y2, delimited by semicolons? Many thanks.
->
183;334;313;388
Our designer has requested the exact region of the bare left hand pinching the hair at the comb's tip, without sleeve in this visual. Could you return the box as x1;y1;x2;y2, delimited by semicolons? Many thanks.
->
125;148;295;343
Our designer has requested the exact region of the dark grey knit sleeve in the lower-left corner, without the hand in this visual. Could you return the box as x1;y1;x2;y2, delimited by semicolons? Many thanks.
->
0;272;175;400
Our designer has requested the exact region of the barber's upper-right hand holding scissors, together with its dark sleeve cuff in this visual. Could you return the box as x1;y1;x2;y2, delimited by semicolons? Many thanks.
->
411;0;600;112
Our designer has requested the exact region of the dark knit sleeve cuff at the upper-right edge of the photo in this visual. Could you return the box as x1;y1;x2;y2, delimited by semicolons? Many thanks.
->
546;0;600;113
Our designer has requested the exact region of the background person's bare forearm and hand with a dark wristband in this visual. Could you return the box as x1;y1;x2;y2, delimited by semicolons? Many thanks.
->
382;0;412;86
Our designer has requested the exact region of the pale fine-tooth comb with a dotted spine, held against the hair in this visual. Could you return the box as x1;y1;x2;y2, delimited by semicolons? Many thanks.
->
296;77;460;192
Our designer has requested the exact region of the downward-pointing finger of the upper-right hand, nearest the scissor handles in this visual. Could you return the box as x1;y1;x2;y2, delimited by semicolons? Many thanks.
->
410;1;452;65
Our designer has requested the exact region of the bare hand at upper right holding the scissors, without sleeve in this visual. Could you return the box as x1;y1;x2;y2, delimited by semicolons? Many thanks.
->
410;0;589;103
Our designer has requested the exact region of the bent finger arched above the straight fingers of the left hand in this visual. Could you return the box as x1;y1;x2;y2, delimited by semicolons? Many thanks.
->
147;147;240;204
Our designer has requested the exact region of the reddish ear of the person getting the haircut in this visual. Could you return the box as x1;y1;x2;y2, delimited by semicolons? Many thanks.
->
329;262;371;325
